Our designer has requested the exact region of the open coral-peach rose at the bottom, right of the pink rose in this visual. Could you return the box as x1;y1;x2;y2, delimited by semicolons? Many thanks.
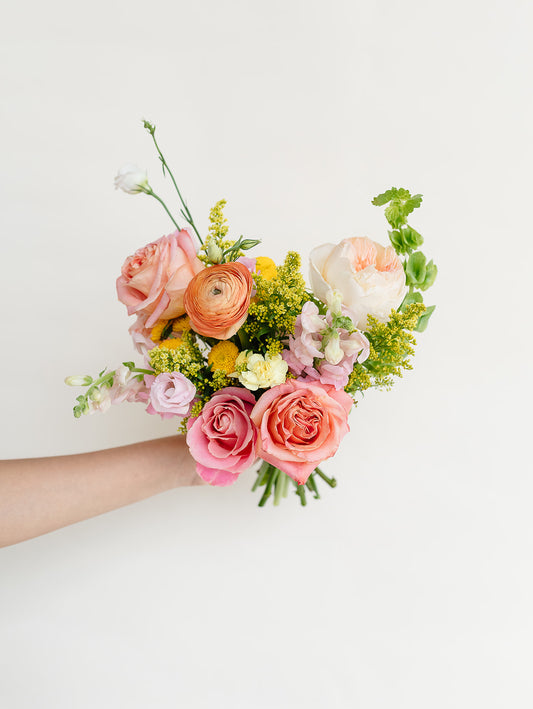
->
250;379;353;485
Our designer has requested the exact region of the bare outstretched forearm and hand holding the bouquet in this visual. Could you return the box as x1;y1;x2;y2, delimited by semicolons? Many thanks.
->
0;436;202;547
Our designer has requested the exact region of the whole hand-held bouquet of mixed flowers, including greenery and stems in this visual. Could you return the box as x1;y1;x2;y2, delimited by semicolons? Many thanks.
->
65;121;437;506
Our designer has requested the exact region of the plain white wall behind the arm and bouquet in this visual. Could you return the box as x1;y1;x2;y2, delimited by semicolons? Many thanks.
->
0;0;533;709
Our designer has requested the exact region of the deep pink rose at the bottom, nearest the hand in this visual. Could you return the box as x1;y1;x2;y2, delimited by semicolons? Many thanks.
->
187;387;257;485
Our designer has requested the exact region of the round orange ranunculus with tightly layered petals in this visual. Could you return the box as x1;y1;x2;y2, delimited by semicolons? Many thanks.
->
184;261;253;340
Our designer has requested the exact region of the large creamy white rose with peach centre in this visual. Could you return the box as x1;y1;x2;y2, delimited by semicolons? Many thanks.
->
310;237;407;330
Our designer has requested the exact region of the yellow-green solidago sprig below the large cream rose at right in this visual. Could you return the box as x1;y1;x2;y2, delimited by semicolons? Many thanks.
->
345;302;426;394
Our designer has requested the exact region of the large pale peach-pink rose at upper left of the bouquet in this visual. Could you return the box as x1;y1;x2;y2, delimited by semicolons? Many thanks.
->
117;229;204;328
